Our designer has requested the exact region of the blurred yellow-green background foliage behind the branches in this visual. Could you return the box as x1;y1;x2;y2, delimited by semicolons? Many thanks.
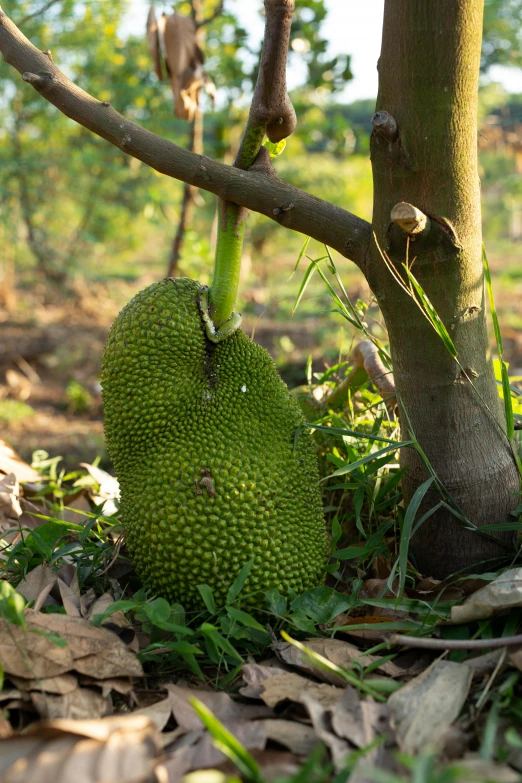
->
0;0;522;312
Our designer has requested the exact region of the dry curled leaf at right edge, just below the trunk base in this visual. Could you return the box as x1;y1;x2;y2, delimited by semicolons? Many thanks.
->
451;568;522;623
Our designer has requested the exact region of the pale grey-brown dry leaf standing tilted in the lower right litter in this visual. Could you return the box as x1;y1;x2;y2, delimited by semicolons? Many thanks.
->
388;660;473;753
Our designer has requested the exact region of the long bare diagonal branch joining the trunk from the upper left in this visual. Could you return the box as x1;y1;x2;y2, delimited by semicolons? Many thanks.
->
0;9;371;271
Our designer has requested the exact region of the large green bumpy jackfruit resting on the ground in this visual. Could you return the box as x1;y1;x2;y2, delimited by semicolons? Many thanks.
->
101;278;328;610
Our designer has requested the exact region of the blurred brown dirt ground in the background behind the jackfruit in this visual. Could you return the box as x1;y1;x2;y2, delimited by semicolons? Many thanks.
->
0;258;522;469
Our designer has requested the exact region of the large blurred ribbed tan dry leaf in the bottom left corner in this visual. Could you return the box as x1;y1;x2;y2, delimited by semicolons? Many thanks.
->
0;715;160;783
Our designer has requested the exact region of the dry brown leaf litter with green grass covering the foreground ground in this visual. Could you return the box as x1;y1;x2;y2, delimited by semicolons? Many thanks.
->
0;448;522;783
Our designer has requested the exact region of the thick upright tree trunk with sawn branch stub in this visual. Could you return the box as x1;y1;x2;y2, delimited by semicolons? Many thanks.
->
366;0;520;577
